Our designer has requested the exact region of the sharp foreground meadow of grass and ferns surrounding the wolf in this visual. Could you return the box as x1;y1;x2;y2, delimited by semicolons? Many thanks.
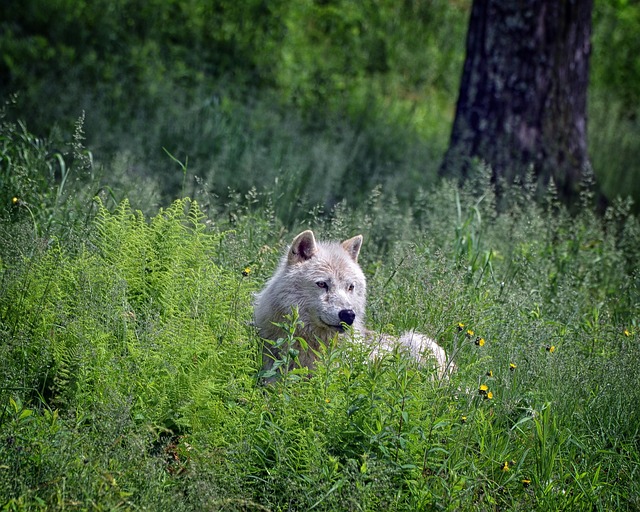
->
0;143;640;511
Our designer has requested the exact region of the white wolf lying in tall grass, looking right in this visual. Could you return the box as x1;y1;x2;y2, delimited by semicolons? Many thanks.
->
254;231;453;377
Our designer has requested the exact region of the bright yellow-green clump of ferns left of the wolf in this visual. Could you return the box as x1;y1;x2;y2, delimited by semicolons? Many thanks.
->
0;199;254;429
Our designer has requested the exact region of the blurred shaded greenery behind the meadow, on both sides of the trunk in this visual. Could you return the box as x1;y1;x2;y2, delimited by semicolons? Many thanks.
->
0;0;640;214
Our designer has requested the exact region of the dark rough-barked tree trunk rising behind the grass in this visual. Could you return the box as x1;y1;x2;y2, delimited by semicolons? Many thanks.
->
440;0;593;199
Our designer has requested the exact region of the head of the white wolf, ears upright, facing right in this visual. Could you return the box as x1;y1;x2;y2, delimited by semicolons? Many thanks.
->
255;231;366;342
